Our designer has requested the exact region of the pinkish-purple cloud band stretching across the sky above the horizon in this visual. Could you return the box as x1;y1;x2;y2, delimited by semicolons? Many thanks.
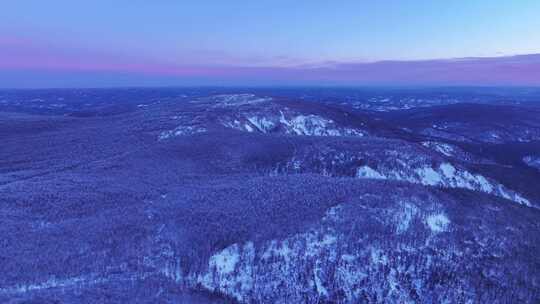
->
0;36;540;85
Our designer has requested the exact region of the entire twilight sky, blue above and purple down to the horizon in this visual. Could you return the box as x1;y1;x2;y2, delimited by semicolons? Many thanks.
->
0;0;540;87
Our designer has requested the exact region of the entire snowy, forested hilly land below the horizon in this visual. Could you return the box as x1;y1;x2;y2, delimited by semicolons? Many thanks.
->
0;88;540;304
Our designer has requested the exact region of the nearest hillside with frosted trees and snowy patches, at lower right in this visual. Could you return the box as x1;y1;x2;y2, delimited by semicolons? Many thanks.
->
192;189;531;303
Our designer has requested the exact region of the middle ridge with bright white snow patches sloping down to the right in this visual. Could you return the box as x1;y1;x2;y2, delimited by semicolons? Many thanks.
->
270;140;532;206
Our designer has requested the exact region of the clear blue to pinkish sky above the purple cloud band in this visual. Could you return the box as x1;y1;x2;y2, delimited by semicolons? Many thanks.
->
0;0;540;84
